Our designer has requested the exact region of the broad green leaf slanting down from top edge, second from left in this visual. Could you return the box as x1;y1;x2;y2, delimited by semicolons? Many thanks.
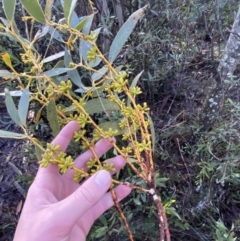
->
20;0;46;24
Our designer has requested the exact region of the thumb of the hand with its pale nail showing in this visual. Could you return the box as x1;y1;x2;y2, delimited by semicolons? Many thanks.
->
58;170;112;226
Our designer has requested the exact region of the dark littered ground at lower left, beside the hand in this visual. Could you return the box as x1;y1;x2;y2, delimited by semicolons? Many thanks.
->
0;108;37;241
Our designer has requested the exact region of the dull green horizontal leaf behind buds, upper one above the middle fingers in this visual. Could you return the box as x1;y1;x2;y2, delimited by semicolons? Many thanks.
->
83;98;120;115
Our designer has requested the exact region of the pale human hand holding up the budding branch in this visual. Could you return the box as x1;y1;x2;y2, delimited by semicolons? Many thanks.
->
14;121;131;241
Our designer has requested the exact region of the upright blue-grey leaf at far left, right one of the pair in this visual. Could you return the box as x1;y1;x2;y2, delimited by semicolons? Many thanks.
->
18;89;30;127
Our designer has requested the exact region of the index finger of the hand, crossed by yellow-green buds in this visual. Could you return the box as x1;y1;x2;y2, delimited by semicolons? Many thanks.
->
38;121;79;172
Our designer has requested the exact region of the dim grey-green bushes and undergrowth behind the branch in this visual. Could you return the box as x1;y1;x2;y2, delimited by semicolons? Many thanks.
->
0;0;240;241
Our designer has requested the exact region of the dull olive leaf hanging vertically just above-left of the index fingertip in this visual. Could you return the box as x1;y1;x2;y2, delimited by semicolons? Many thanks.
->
47;100;60;136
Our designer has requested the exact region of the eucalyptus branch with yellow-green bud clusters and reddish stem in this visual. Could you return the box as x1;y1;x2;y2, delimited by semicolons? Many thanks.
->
1;0;170;241
